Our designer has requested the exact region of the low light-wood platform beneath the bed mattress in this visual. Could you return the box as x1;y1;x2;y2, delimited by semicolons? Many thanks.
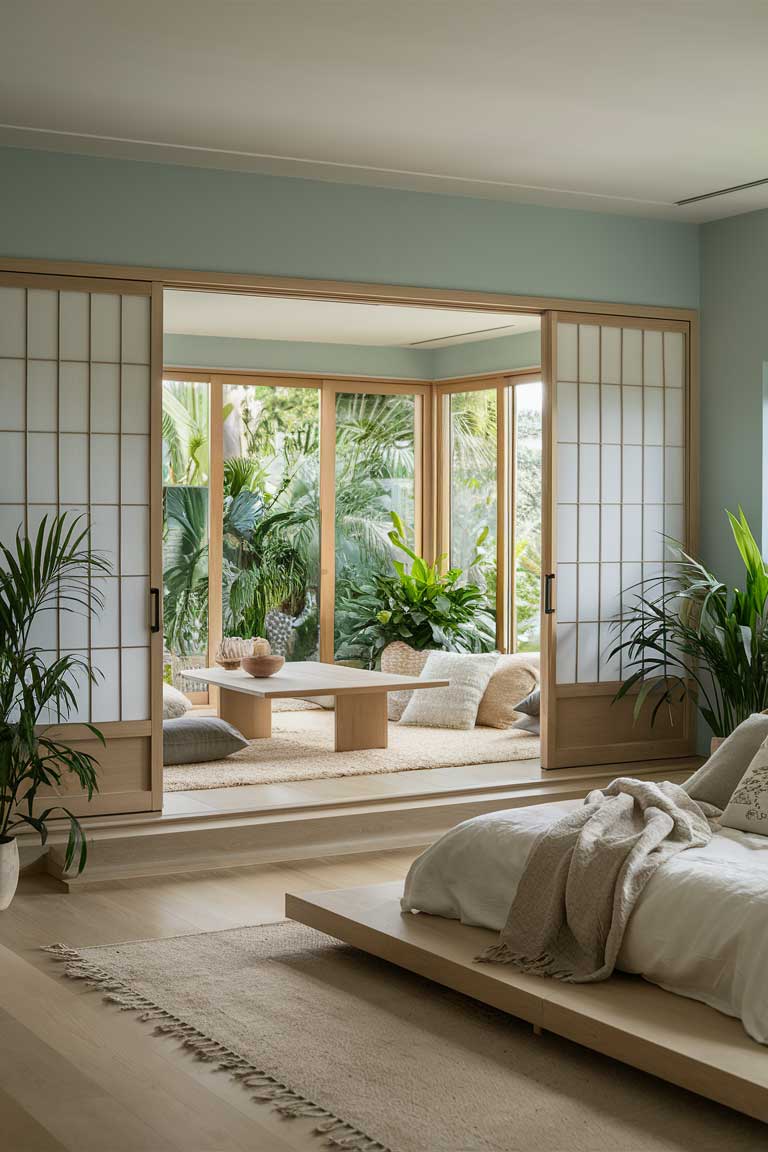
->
286;884;768;1122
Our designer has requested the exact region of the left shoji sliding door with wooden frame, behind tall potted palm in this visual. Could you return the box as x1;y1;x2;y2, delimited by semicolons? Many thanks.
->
0;275;162;813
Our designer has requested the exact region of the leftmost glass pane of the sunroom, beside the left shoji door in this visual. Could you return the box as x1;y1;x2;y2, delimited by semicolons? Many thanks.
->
162;380;210;692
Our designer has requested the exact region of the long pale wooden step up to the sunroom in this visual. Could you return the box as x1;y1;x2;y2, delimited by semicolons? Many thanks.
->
27;760;699;889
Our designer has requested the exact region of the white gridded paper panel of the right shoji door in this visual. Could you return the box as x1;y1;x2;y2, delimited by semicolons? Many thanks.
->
556;324;685;684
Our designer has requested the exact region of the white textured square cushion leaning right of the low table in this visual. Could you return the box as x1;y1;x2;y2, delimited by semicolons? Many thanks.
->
400;652;499;728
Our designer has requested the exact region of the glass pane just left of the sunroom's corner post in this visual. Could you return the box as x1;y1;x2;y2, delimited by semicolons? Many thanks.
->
334;393;417;660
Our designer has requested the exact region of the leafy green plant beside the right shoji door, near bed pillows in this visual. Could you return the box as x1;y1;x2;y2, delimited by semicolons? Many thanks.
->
611;508;768;736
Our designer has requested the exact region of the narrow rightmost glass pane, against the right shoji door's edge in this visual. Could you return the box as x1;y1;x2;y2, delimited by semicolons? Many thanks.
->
514;381;541;652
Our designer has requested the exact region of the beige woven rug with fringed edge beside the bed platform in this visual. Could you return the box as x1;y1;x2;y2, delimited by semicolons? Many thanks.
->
51;922;766;1152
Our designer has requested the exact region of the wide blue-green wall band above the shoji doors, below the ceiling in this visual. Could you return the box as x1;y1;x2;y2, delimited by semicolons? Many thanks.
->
0;149;699;308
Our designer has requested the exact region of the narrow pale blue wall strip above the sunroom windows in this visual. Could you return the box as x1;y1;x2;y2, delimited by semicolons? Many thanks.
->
162;332;540;380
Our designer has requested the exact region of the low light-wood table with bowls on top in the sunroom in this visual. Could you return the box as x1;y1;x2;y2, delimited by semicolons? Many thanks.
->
182;660;449;752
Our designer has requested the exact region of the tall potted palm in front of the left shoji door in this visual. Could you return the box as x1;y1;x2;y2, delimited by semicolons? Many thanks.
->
0;514;111;909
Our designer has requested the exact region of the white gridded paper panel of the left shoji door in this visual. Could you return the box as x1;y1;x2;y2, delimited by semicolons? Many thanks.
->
0;286;151;722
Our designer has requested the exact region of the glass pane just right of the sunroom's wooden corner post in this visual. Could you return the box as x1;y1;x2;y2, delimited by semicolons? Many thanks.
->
449;388;496;615
